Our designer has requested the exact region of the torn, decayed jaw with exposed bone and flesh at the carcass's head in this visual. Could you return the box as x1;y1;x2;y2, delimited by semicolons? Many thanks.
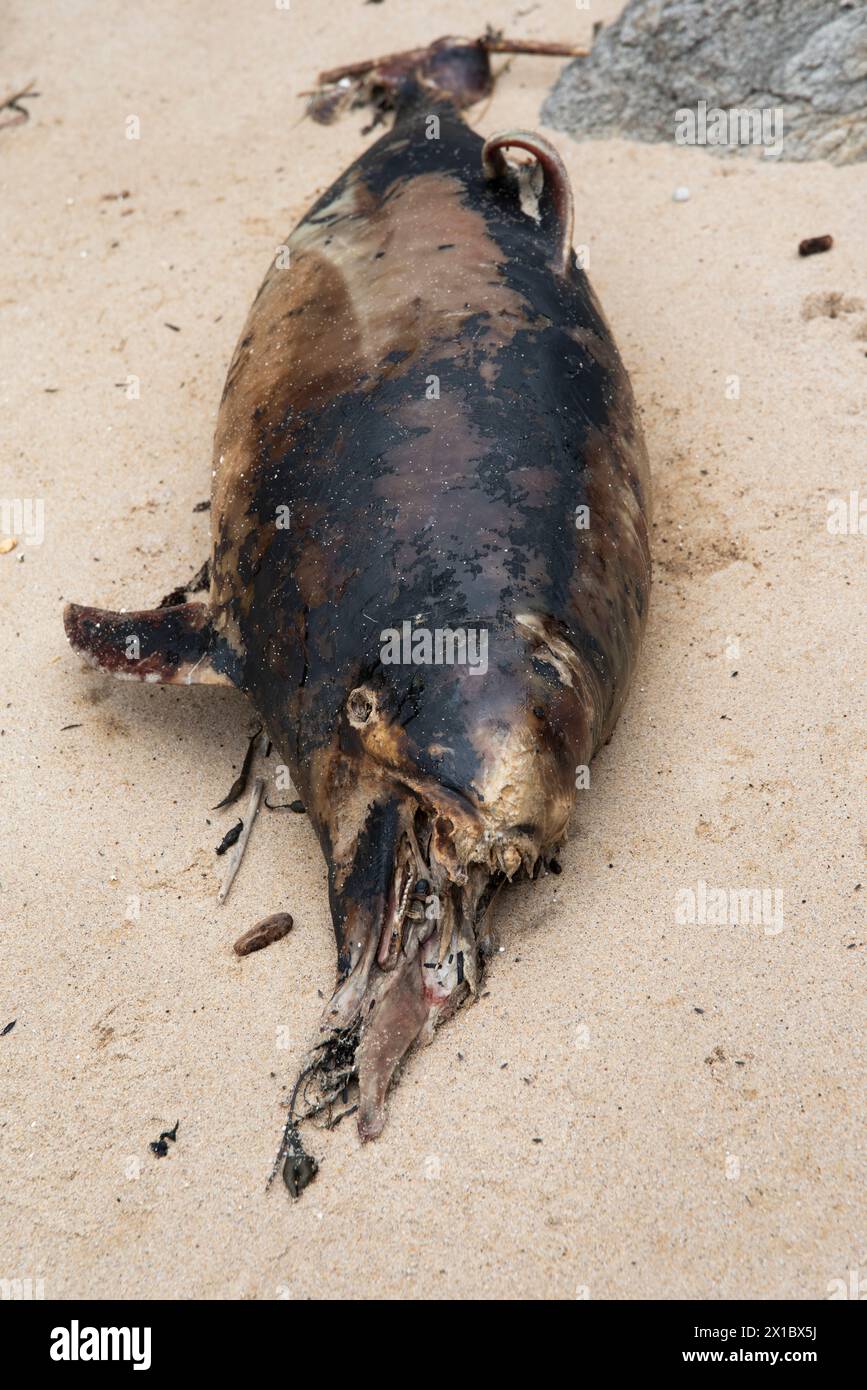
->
275;795;538;1167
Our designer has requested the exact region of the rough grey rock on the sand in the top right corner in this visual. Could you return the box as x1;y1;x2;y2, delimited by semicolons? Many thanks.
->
542;0;867;164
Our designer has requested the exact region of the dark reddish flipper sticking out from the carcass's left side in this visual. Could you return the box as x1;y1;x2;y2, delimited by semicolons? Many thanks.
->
64;603;240;685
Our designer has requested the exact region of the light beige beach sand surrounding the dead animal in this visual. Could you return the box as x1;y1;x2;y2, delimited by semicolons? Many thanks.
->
0;0;867;1298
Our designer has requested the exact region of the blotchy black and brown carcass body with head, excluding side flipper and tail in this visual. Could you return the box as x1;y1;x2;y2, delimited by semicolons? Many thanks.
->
69;97;650;1136
